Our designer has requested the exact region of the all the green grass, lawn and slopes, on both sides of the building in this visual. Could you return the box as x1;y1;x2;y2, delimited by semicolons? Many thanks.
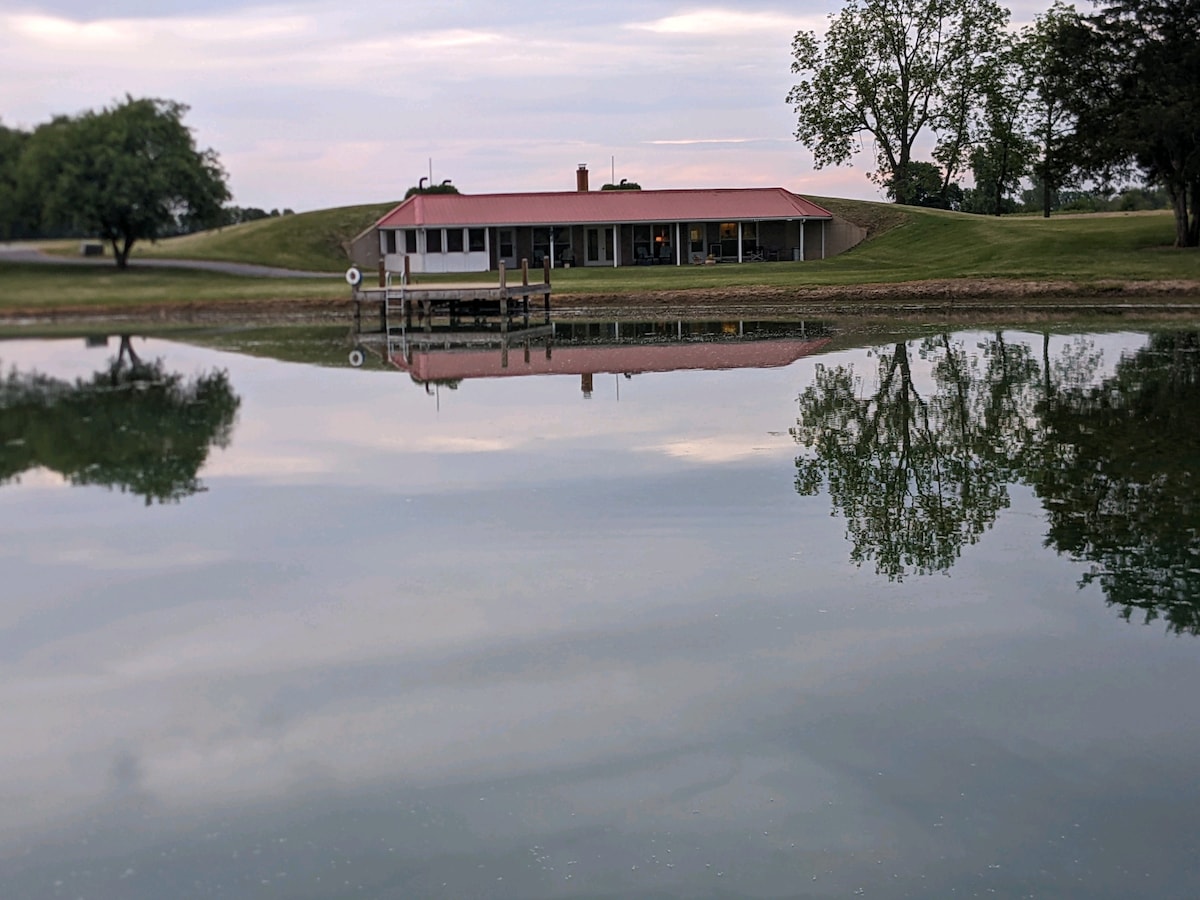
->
0;199;1200;310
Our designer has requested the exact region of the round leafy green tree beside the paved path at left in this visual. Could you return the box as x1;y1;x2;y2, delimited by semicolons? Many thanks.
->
20;96;229;269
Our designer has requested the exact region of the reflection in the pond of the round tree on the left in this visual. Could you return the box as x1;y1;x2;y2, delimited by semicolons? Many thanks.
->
0;336;241;505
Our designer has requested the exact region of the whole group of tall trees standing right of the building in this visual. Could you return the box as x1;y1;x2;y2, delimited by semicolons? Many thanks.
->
787;0;1200;247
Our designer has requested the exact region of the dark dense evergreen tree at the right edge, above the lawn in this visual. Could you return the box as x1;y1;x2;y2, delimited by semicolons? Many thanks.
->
1057;0;1200;247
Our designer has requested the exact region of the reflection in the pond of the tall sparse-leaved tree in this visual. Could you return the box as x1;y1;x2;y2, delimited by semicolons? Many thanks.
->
792;335;1037;580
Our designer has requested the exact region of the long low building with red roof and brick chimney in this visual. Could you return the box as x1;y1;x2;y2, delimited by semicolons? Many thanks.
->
352;166;865;274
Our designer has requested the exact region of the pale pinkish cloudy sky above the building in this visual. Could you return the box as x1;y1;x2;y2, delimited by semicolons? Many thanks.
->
0;0;1049;212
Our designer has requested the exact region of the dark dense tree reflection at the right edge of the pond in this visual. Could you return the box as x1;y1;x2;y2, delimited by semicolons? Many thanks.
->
1028;334;1200;635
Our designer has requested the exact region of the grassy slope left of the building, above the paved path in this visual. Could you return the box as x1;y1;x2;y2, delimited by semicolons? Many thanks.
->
133;202;396;272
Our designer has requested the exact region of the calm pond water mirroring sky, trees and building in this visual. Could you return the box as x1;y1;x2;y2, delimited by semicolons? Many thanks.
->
0;323;1200;900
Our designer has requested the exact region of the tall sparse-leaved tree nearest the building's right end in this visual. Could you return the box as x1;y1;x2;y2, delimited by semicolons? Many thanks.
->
787;0;1008;203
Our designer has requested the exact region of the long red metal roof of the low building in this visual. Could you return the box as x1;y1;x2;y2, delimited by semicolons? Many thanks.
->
377;187;833;228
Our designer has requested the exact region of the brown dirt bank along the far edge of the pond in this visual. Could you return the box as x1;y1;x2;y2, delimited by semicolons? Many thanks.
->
0;278;1200;325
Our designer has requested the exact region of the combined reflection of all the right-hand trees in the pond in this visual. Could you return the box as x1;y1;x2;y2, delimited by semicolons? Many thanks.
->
792;332;1200;634
